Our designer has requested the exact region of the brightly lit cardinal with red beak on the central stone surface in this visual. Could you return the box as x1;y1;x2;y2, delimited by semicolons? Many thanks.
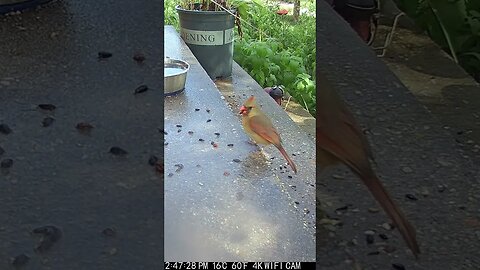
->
240;96;297;173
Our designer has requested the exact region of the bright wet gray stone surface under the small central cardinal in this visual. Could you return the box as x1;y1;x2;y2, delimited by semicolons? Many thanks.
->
165;26;315;261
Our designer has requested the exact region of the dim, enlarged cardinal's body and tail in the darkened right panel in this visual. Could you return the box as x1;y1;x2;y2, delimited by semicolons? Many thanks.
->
316;71;420;257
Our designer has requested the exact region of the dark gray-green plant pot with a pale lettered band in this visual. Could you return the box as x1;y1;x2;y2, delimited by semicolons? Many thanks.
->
176;0;241;79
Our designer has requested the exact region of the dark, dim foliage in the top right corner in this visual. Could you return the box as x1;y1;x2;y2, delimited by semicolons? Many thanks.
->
396;0;480;76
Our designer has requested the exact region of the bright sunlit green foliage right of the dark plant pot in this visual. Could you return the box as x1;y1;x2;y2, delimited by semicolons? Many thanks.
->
234;1;316;115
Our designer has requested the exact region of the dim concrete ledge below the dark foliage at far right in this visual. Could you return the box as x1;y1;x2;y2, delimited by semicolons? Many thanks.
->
380;26;480;164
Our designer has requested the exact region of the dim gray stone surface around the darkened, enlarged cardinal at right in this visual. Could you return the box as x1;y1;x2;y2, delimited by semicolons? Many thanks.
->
317;2;480;269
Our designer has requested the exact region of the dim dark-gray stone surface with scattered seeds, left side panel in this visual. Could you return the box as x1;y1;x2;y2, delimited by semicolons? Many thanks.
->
0;1;163;269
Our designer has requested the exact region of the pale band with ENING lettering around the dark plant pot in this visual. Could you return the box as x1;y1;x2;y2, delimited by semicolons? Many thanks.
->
180;28;234;46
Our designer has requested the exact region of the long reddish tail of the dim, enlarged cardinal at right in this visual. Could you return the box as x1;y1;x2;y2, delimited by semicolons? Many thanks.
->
361;175;420;257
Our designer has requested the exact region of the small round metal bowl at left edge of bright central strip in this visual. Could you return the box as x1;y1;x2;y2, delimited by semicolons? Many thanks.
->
163;57;190;96
